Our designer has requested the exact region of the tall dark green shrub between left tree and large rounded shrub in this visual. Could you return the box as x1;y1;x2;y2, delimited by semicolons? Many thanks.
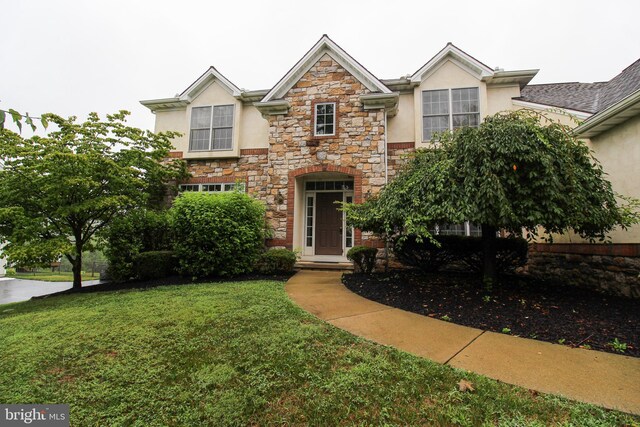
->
102;209;171;282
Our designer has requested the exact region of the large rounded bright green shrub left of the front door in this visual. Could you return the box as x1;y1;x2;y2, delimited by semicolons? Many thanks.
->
169;192;265;277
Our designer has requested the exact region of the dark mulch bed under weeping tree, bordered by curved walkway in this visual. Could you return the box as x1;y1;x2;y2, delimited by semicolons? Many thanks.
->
343;270;640;357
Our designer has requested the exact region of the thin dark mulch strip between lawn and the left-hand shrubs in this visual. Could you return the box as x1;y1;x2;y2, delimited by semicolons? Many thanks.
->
33;272;295;299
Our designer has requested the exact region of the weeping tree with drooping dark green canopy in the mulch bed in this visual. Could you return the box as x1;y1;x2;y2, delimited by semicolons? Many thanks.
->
345;111;636;283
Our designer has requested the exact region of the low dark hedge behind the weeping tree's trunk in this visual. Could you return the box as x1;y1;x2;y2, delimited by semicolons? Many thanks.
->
393;235;528;273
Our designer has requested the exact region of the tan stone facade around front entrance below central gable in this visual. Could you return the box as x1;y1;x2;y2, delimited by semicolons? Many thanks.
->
267;55;385;247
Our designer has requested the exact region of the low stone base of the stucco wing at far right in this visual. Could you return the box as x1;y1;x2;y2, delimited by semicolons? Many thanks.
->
524;244;640;298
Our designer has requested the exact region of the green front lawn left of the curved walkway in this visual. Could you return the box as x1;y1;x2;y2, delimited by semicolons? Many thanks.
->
0;281;638;426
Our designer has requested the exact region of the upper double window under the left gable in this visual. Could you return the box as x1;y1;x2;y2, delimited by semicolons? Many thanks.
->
189;105;233;151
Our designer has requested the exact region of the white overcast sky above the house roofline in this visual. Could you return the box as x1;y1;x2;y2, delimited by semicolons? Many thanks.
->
0;0;640;134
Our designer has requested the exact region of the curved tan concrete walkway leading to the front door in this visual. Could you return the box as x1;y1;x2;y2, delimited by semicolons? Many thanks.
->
286;270;640;415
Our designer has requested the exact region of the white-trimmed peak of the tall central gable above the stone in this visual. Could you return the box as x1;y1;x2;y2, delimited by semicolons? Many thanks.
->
261;34;391;103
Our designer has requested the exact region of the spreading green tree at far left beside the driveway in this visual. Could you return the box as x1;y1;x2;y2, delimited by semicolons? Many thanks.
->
0;111;185;288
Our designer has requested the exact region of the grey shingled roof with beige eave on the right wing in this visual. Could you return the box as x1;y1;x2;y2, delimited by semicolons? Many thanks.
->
515;59;640;138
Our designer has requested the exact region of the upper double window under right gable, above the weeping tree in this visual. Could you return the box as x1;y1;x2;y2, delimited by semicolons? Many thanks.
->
422;87;480;141
